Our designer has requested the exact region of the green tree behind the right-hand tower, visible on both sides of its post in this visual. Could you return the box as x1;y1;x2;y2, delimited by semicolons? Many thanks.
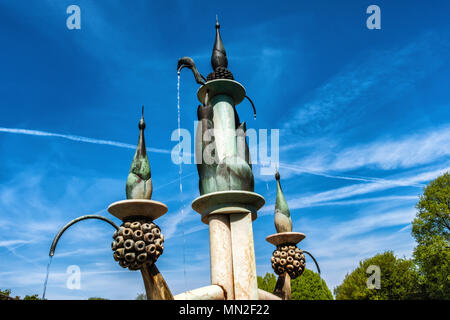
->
258;269;333;300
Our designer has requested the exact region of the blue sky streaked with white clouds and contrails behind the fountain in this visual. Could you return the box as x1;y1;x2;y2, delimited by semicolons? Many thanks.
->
0;0;450;299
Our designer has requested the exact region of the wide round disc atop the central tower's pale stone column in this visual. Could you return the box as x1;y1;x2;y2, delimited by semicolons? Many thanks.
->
192;190;265;224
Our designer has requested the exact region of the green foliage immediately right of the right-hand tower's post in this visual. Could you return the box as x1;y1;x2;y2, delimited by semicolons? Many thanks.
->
291;269;333;300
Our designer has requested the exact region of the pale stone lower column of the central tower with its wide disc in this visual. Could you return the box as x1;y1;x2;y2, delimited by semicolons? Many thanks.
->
192;190;265;300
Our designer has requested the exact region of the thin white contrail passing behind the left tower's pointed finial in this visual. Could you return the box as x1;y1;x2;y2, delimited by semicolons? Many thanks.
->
0;127;171;154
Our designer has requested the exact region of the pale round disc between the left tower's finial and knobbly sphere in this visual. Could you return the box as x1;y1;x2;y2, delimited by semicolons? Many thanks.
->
108;199;167;221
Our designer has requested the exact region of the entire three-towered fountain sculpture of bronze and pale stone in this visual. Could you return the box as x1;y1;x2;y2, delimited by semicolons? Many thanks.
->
44;21;320;300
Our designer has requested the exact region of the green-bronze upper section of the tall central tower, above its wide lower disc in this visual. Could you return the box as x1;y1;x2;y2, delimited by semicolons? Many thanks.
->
177;21;256;195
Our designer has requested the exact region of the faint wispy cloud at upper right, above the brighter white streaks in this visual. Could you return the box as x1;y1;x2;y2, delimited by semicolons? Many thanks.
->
284;33;448;133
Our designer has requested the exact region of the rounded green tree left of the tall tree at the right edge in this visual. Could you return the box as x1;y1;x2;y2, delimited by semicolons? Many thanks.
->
334;251;419;300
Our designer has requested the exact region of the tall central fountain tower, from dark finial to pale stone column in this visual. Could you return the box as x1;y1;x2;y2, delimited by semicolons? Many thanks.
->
178;17;265;299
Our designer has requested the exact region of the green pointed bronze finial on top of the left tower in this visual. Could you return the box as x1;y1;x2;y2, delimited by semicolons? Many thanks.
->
126;106;153;200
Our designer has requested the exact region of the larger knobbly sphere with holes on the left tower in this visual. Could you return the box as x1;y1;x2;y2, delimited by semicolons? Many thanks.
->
111;219;164;270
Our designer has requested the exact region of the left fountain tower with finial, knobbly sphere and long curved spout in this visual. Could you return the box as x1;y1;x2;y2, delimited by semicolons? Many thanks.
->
50;107;173;300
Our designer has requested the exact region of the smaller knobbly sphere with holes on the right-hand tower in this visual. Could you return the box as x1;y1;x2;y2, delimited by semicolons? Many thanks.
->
271;244;305;279
